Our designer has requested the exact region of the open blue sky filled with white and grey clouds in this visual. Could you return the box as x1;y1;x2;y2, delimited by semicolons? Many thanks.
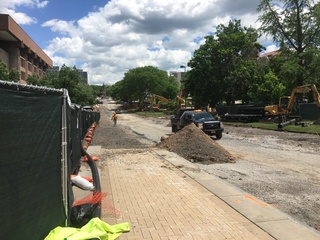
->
0;0;276;84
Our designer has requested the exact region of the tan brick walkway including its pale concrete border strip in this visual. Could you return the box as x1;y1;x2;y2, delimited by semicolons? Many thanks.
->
84;146;320;240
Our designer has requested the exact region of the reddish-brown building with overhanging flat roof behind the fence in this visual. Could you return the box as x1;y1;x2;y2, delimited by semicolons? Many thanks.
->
0;14;53;83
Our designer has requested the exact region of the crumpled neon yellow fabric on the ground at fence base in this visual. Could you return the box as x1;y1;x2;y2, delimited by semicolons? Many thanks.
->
45;218;130;240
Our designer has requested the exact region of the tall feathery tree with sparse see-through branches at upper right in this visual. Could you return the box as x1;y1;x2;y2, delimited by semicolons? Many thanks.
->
257;0;320;86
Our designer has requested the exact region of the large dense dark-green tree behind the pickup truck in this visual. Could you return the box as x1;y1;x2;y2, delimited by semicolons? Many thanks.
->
186;20;263;106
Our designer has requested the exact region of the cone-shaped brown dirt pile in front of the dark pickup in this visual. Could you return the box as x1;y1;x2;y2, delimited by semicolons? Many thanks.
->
157;124;235;164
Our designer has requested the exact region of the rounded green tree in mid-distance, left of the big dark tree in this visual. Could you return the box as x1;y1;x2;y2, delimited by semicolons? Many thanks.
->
120;66;169;107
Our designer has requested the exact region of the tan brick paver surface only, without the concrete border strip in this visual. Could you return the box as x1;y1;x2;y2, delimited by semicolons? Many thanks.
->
101;149;273;240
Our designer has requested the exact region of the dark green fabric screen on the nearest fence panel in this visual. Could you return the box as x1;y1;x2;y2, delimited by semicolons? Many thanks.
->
0;85;66;240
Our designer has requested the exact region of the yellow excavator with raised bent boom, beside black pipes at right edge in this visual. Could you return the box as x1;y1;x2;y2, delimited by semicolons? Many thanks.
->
264;84;320;122
